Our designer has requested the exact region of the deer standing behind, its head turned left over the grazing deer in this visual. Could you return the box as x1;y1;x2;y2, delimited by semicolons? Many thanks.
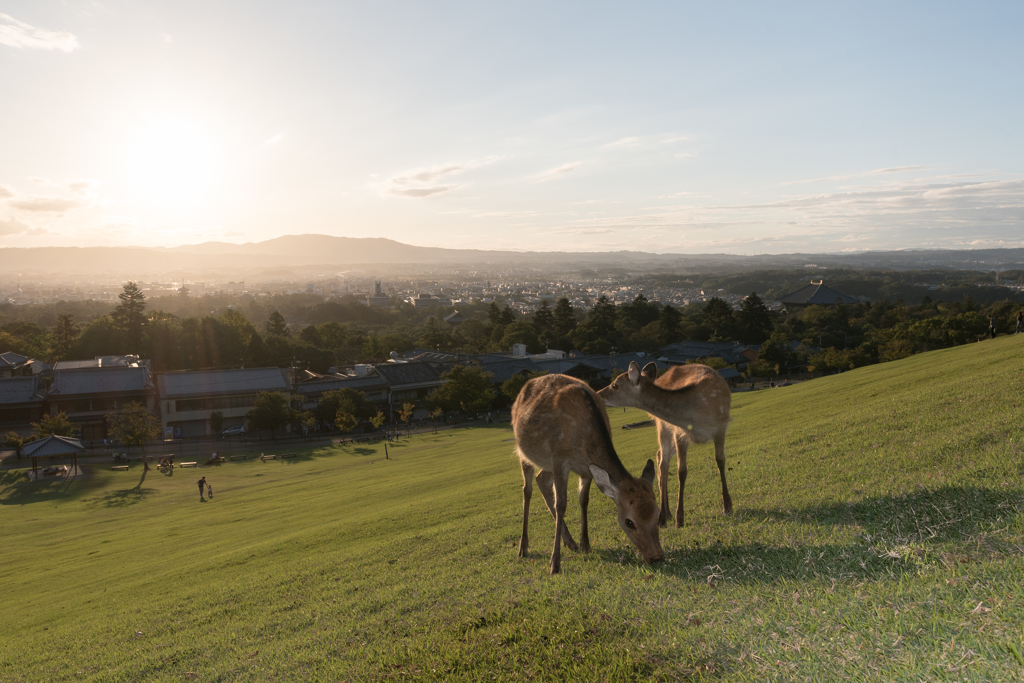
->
598;361;732;526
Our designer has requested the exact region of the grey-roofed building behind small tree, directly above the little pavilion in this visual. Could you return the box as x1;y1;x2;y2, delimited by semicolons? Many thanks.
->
47;355;157;441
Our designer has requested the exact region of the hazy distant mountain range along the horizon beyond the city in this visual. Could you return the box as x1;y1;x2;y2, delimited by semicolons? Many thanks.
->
0;234;1024;281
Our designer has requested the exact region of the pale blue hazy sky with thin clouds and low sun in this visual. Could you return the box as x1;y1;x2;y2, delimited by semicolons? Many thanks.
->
0;0;1024;254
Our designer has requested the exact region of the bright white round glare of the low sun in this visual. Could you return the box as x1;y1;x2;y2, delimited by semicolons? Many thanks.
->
122;119;224;213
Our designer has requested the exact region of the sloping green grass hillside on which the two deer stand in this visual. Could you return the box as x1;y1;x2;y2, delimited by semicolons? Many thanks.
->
0;337;1024;681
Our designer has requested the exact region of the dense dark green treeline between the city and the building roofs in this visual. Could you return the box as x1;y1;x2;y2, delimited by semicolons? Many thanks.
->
0;273;1021;375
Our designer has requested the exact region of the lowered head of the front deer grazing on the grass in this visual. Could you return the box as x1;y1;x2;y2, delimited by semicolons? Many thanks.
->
590;458;665;564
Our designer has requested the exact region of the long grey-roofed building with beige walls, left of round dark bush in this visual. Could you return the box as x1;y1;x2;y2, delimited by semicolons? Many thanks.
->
157;368;292;438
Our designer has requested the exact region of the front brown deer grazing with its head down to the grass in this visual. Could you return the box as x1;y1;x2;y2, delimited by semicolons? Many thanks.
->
512;375;665;573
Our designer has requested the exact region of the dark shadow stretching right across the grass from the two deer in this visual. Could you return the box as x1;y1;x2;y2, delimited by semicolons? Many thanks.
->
528;486;1024;586
